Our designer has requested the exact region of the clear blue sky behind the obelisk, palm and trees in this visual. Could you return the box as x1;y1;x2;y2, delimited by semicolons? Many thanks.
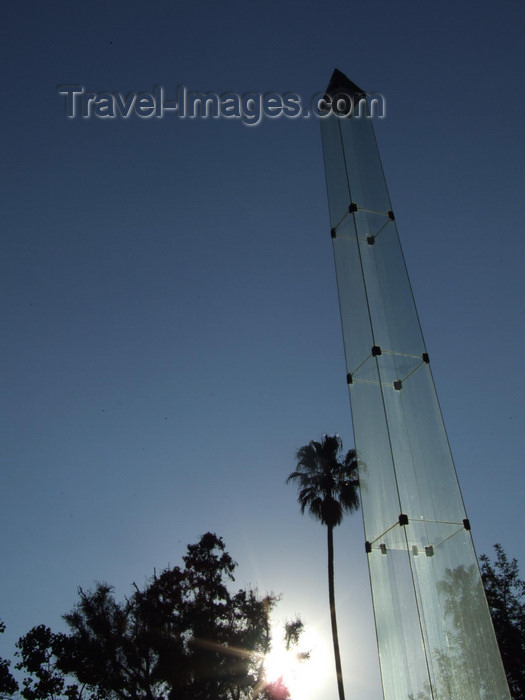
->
0;0;525;700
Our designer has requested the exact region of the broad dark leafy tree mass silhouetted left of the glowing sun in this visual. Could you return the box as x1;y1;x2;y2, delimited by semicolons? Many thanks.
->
10;533;302;700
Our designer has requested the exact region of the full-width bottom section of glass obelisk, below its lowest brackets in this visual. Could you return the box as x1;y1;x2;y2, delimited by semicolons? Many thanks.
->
368;522;509;700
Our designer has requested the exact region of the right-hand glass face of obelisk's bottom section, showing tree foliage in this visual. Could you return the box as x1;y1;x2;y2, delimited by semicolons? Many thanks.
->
406;523;509;700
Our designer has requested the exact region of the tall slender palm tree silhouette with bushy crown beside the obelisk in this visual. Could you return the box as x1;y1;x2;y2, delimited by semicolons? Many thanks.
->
286;435;359;700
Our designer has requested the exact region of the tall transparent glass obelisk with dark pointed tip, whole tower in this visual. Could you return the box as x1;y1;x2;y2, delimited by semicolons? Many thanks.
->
321;71;510;700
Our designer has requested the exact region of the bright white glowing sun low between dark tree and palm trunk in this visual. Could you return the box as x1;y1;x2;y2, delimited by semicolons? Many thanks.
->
264;630;329;700
